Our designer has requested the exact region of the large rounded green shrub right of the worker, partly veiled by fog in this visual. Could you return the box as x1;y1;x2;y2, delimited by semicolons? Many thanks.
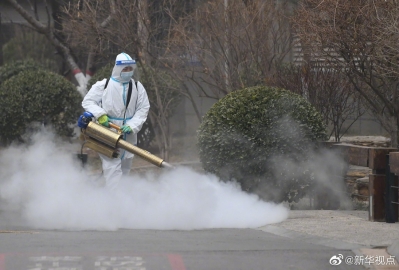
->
198;86;326;202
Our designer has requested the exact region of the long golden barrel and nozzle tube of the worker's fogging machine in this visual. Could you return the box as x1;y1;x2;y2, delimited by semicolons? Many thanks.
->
83;122;173;168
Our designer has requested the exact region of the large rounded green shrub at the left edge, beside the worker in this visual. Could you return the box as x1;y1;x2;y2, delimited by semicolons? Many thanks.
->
0;70;81;144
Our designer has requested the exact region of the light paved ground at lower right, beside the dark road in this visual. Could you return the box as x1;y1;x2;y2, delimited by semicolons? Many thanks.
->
259;210;399;269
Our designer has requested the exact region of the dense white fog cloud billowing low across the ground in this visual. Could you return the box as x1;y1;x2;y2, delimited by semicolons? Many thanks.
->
0;128;288;230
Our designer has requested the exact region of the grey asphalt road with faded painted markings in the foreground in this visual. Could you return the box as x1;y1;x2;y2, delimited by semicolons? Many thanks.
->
0;226;364;270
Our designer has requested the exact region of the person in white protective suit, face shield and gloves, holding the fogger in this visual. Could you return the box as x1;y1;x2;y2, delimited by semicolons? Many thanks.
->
82;53;150;188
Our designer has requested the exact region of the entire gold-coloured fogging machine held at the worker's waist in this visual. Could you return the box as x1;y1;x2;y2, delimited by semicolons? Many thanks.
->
78;112;173;168
